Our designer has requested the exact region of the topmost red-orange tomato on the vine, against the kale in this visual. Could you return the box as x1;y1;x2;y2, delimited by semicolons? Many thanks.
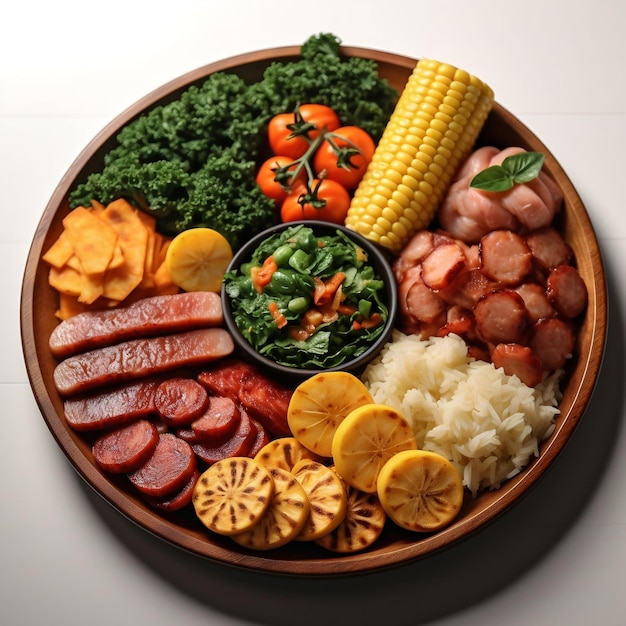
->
267;104;340;159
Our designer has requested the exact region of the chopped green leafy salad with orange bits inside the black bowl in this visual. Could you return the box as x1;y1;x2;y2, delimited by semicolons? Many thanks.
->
224;224;388;369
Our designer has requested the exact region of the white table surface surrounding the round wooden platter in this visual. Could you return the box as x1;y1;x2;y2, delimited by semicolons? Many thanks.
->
0;0;626;626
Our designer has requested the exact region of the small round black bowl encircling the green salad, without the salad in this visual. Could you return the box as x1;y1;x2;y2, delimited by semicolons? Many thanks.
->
222;220;398;380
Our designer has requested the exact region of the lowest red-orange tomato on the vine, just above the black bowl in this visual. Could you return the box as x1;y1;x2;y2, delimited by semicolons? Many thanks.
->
280;179;350;224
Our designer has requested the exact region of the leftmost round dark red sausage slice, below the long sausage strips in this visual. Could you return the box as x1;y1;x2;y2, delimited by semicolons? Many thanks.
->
92;420;159;474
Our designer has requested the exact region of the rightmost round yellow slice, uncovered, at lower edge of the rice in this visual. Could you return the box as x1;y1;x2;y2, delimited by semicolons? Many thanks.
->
377;450;464;533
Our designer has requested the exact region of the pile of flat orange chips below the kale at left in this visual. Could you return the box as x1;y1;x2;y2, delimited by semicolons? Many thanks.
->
42;199;179;319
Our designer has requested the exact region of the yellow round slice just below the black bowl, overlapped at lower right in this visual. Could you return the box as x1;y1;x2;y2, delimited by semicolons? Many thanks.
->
287;372;374;457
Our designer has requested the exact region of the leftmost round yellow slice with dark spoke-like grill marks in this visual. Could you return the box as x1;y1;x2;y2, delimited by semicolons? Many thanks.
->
192;457;275;535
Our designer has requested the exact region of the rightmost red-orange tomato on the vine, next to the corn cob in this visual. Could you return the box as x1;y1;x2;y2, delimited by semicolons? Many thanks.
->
313;126;376;190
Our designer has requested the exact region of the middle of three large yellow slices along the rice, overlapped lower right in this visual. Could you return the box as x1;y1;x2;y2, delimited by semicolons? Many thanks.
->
332;404;417;493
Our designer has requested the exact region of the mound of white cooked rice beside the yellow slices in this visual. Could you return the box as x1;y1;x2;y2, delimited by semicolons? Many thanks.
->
363;331;561;496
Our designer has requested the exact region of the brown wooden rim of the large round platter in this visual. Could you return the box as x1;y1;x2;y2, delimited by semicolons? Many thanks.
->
20;46;608;576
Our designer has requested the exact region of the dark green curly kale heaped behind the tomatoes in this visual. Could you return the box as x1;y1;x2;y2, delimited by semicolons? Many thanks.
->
69;34;397;249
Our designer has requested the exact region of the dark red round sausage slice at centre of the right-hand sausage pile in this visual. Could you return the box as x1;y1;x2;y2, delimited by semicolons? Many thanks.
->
474;289;529;344
